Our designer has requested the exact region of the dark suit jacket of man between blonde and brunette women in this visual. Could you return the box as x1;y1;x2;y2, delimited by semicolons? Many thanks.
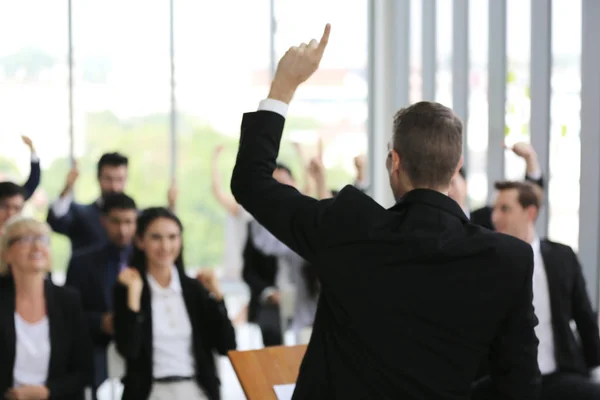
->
65;244;126;388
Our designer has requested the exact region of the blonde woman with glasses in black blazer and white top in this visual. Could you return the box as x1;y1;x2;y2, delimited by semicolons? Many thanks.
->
0;217;93;400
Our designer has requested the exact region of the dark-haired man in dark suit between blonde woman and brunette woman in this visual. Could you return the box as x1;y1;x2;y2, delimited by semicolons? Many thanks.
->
65;193;137;396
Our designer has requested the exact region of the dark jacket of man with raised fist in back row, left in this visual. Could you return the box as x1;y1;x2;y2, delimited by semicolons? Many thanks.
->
46;202;108;254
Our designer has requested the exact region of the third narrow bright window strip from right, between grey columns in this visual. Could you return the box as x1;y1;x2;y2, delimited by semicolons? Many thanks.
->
467;0;488;208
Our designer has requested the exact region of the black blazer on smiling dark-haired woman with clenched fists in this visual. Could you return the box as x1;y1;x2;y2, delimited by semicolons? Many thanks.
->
114;271;236;400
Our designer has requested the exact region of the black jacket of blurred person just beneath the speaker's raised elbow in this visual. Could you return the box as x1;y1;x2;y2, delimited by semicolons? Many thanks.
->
242;222;278;322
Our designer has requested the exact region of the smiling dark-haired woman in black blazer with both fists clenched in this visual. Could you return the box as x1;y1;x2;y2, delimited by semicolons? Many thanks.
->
114;208;236;400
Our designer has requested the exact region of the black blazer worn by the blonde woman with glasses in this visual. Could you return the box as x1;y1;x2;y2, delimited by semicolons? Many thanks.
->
0;280;92;400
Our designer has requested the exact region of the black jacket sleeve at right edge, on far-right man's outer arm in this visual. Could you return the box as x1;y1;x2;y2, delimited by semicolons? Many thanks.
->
570;250;600;369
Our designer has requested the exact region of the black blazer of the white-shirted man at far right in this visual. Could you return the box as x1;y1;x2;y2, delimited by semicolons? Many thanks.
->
540;240;600;375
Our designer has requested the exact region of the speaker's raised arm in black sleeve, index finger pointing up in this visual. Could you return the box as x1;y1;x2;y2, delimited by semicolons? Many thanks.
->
231;25;331;261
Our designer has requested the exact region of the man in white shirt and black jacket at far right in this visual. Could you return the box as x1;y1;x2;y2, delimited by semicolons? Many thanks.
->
492;182;600;400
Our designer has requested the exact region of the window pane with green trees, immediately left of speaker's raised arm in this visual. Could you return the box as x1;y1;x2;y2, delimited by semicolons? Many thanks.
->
174;0;272;267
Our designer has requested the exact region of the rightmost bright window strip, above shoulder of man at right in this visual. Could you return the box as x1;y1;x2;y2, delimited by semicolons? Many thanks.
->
547;0;581;249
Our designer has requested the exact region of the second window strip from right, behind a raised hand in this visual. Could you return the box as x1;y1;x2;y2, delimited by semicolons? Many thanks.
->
504;0;531;180
